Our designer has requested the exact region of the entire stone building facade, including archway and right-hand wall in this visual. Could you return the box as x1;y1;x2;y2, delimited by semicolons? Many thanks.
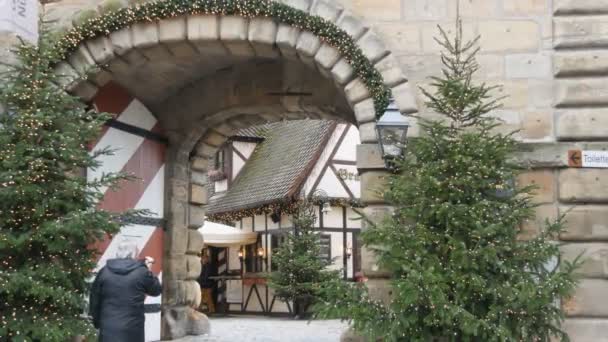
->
0;0;608;341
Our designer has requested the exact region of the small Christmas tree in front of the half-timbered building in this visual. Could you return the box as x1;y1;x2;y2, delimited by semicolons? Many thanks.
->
270;200;339;317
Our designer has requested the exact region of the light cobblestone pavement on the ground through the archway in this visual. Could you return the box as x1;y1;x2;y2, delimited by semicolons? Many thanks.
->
169;316;347;342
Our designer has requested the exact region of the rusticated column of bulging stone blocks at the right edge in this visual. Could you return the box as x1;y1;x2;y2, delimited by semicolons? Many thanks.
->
553;0;608;336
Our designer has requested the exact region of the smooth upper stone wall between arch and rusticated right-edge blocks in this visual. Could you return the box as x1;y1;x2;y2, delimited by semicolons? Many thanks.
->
342;0;555;142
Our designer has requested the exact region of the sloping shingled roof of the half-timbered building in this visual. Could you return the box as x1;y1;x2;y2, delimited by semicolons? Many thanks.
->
207;120;335;215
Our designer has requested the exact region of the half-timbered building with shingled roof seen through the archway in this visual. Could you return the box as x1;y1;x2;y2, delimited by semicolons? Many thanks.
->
203;120;361;314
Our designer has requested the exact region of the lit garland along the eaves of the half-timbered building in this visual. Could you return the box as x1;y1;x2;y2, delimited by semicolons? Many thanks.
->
207;198;364;223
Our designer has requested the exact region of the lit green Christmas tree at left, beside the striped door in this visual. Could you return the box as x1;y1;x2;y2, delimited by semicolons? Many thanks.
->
0;32;125;342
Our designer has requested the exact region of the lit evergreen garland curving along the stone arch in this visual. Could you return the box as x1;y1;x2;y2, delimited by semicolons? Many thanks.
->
55;0;391;118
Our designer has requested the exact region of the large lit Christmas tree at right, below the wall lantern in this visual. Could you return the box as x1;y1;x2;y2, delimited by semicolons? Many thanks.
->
318;23;578;341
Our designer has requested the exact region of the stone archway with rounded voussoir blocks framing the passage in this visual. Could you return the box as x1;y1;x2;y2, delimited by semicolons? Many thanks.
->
57;0;416;338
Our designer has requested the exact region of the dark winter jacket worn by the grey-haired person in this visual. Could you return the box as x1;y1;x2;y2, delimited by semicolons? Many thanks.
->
89;259;161;342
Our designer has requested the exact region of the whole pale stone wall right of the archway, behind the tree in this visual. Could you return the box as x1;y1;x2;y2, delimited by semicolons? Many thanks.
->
342;0;608;341
